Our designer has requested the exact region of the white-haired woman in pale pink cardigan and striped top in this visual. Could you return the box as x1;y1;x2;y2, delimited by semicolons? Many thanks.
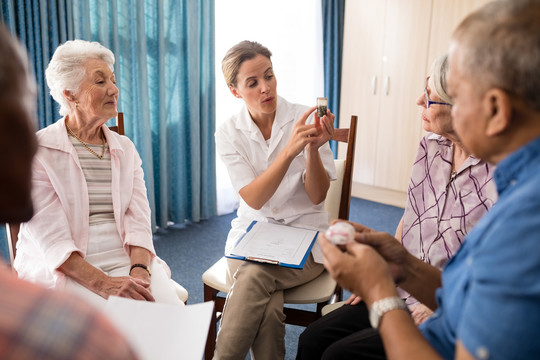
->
14;40;186;307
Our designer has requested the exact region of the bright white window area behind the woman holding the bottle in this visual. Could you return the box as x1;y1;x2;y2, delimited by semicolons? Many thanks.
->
215;0;324;214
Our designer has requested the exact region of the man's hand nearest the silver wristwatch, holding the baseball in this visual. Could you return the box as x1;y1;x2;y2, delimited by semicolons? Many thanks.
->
319;233;396;304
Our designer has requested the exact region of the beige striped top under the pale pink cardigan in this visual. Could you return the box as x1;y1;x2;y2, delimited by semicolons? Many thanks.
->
69;135;115;226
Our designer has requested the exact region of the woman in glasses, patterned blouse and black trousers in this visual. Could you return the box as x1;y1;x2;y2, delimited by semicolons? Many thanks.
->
297;55;497;360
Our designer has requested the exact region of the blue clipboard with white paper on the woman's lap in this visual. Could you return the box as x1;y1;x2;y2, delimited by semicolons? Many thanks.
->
225;221;319;269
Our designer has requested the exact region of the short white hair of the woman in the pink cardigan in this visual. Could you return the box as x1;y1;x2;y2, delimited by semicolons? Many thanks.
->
45;40;114;116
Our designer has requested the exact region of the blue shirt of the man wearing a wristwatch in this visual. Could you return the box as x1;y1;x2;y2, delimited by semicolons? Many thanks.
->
421;138;540;359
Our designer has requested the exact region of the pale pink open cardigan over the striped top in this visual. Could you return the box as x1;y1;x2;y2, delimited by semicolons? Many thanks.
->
14;118;155;287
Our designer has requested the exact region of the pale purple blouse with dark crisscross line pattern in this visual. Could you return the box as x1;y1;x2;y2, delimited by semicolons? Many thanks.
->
401;133;497;305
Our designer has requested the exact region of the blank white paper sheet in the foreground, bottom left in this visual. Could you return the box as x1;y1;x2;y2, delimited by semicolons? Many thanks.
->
105;296;214;360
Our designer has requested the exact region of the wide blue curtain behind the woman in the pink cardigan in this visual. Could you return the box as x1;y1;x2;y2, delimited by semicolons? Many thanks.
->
1;0;216;228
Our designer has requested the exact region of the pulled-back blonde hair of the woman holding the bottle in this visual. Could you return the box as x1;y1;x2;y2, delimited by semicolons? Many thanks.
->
221;40;272;86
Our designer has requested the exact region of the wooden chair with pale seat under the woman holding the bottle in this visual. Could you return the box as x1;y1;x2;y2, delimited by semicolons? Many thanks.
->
202;116;357;360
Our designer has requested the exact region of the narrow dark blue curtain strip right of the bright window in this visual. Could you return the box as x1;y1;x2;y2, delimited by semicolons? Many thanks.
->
321;0;345;157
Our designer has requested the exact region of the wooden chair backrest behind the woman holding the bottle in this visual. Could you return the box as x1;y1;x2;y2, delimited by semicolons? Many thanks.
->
324;115;358;220
